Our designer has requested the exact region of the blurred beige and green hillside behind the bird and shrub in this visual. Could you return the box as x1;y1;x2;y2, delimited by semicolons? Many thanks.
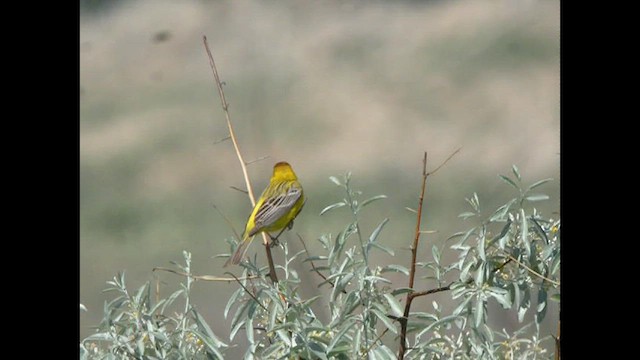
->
79;0;560;354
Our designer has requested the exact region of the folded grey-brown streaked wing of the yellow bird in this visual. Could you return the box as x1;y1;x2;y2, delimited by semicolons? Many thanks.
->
249;183;302;236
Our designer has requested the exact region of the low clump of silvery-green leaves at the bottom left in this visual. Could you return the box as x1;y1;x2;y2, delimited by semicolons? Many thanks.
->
80;251;227;359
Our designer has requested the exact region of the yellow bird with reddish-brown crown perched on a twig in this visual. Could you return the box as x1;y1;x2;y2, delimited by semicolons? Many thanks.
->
224;161;305;267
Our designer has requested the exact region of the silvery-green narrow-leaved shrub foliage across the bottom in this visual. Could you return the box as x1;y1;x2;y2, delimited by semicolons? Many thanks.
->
80;166;560;360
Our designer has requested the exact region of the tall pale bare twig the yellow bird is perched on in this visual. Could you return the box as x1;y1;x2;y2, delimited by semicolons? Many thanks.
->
202;35;278;283
